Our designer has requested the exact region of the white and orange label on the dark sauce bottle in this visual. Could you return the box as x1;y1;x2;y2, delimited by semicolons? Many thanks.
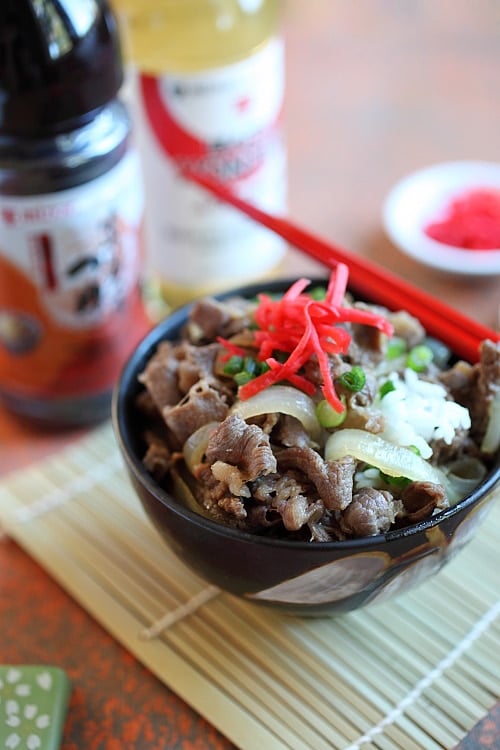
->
0;152;145;397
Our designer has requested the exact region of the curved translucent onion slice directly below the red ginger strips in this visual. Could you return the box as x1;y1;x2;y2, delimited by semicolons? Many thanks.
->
230;385;321;443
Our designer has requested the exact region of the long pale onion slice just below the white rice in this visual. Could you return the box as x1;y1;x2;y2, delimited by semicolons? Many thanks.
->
325;428;454;500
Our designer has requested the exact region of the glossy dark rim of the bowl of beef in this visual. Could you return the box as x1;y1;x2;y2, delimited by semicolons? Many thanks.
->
111;277;500;551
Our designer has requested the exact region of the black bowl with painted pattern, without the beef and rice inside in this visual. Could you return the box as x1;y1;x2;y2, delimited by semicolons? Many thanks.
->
113;280;500;615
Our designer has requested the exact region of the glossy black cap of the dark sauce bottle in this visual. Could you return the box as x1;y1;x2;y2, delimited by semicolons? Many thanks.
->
0;0;123;137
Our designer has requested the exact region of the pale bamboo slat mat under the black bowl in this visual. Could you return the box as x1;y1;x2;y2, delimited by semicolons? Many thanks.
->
0;425;500;750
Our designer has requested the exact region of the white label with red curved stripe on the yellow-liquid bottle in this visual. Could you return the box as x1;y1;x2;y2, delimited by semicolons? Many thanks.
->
136;38;286;288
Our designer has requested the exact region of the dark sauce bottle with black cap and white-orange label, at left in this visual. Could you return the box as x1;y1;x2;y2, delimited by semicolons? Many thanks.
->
0;0;149;427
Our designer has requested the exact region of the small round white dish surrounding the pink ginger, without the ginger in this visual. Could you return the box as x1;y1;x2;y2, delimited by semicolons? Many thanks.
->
383;161;500;276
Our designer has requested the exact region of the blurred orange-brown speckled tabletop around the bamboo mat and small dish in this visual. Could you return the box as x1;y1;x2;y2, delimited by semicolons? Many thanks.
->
0;0;500;750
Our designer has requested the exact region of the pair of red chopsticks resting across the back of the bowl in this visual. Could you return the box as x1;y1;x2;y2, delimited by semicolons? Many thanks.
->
183;171;500;362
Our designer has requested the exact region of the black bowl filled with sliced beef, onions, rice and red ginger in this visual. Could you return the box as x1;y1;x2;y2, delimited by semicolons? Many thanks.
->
113;268;500;614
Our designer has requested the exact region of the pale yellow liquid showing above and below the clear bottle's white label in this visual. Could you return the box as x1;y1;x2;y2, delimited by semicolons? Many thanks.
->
114;0;283;318
